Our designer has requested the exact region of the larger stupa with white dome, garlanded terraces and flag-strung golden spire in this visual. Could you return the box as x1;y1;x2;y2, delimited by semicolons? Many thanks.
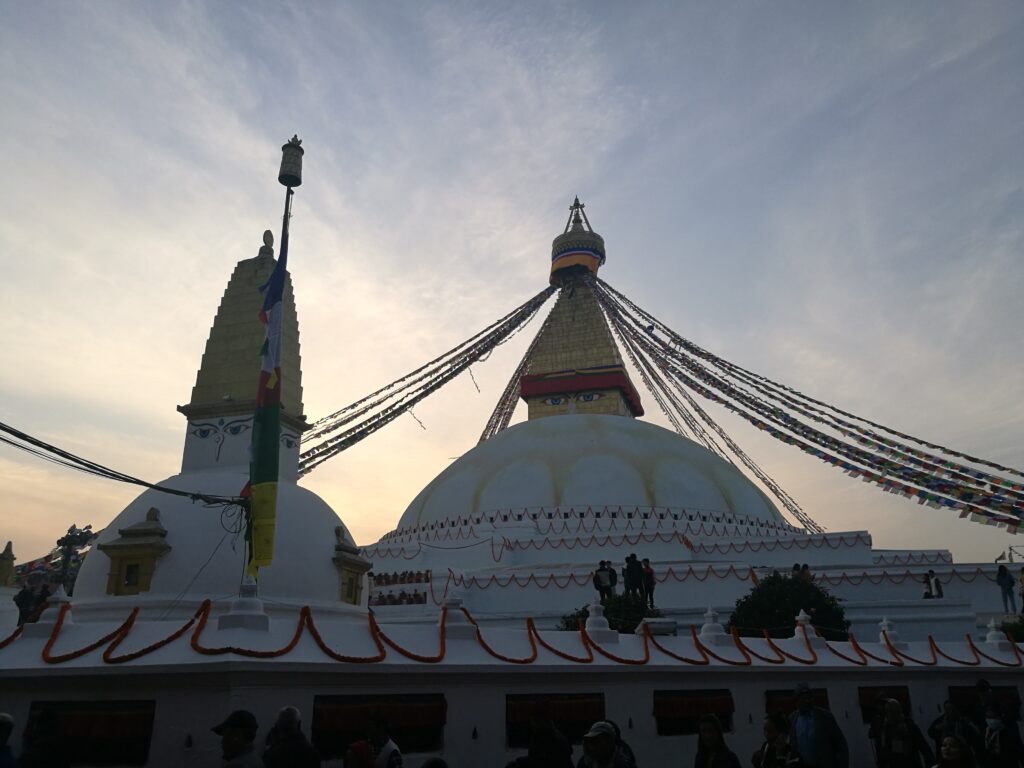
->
362;199;1001;638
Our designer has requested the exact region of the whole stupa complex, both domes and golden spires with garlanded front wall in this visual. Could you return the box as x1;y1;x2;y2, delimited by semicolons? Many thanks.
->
0;188;1024;768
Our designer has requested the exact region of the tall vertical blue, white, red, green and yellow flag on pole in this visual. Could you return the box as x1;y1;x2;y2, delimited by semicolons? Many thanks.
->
243;218;288;578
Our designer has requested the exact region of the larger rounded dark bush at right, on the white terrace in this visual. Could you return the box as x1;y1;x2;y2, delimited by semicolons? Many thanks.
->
727;572;850;640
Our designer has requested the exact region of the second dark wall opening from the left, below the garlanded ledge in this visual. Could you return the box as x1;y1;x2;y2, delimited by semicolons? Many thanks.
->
312;693;447;760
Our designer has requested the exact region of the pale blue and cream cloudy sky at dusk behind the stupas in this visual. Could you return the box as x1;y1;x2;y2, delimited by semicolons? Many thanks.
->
0;0;1024;561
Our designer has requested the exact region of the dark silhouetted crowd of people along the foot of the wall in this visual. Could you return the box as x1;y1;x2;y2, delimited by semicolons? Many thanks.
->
0;680;1024;768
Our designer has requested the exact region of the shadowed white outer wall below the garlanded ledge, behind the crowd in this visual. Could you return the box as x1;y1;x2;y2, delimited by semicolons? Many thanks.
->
4;662;1011;768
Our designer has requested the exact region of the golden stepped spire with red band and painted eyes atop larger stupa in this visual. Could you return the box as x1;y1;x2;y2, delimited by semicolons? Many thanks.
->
519;198;643;419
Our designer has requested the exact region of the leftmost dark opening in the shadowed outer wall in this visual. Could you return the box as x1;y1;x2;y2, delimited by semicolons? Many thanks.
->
25;700;156;766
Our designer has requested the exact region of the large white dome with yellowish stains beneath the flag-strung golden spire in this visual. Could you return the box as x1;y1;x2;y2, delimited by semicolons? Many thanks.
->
398;414;790;531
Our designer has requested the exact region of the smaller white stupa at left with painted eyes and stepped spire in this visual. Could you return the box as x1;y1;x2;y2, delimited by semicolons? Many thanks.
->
75;231;369;616
